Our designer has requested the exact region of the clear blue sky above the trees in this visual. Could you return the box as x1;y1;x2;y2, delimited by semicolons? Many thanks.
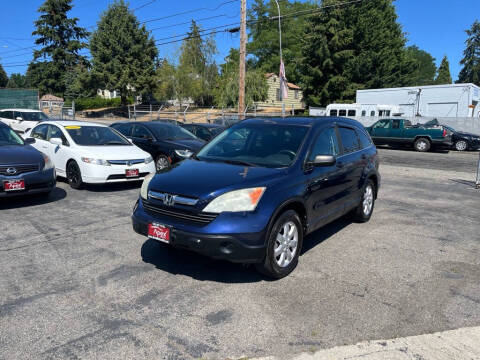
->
0;0;480;80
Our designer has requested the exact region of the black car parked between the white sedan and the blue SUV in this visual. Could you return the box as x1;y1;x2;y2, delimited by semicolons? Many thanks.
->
111;121;205;171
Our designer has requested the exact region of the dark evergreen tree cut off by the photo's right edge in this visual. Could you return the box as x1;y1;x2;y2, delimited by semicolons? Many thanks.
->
458;21;480;86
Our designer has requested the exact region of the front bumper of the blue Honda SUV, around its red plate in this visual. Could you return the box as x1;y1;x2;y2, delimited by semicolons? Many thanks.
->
132;200;266;263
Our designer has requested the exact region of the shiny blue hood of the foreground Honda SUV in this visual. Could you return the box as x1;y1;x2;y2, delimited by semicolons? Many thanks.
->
150;159;286;199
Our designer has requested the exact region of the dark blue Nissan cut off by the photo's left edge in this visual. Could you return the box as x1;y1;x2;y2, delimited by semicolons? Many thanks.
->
0;123;56;198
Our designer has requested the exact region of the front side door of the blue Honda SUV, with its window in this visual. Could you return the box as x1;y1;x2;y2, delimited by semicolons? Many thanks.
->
304;126;345;230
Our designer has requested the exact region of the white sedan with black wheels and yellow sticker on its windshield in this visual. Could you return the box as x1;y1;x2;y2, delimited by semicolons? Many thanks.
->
27;121;155;189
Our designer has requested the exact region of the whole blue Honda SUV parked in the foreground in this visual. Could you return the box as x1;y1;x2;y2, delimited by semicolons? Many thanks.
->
132;117;380;278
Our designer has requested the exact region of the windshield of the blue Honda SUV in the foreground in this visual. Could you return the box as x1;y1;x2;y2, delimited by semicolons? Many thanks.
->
196;123;309;168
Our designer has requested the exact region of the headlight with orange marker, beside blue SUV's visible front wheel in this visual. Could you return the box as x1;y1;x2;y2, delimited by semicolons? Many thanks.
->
203;187;266;214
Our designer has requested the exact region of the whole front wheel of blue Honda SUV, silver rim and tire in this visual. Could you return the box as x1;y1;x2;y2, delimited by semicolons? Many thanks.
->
256;210;303;279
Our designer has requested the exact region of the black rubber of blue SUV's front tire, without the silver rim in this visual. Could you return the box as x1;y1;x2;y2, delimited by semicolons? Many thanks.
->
256;210;303;279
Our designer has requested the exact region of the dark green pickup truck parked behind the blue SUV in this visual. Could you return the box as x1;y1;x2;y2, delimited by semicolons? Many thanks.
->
366;119;452;152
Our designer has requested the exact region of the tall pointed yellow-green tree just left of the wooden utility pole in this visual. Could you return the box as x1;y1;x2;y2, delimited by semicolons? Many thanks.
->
176;21;218;106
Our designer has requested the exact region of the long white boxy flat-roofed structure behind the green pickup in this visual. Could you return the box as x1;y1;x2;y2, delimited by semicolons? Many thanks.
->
356;84;480;118
